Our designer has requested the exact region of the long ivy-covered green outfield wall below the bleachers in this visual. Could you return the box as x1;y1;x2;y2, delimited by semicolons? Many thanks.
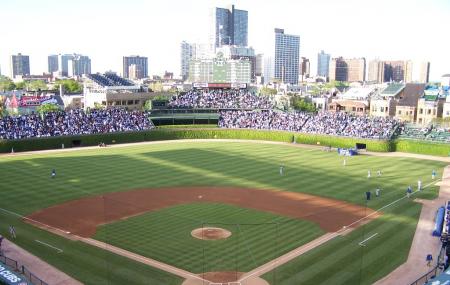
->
0;128;450;156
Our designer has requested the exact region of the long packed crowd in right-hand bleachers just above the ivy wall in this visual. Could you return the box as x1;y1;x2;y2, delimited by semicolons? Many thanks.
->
219;110;400;139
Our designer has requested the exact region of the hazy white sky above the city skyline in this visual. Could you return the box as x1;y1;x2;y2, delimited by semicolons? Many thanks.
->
0;0;450;80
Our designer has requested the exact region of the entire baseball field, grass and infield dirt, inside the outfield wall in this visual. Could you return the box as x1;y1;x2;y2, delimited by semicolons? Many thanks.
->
0;141;446;285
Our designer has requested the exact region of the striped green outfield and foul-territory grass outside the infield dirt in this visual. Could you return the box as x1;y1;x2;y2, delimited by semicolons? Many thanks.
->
0;142;445;284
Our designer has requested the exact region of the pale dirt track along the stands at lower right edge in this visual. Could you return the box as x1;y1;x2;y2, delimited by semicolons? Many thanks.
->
375;166;450;285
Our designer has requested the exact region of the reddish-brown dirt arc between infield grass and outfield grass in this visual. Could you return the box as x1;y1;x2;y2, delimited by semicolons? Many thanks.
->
27;187;378;237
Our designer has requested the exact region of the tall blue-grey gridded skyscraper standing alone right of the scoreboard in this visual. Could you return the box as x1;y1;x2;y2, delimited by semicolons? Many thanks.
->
274;29;300;84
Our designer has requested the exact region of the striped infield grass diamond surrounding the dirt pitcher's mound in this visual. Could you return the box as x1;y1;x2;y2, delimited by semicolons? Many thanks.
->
94;203;324;273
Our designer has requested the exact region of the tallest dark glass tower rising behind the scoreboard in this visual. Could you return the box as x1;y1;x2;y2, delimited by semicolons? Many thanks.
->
211;5;248;47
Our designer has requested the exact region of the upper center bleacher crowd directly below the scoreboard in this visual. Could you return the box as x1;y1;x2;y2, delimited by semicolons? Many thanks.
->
169;89;274;109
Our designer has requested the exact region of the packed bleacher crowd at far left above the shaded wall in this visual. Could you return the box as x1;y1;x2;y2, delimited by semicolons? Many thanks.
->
0;108;154;139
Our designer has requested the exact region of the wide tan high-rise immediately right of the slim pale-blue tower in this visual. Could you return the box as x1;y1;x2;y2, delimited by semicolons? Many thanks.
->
329;57;366;82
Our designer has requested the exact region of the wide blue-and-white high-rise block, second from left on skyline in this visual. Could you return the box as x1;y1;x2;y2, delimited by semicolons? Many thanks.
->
48;53;91;77
